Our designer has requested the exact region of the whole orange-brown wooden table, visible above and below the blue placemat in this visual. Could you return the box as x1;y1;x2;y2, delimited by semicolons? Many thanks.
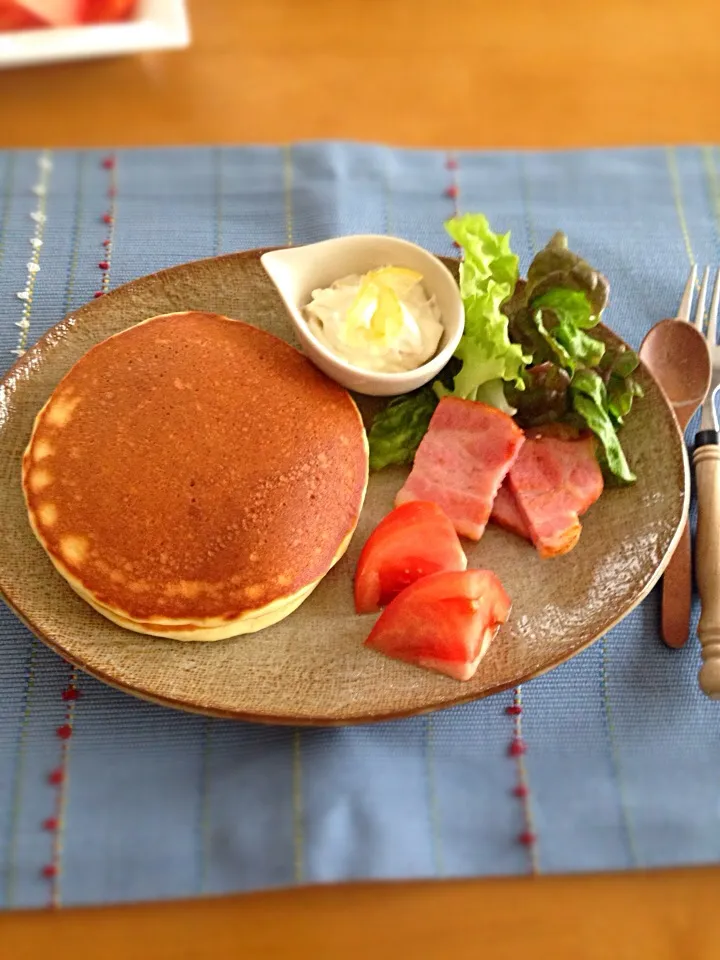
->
0;0;720;960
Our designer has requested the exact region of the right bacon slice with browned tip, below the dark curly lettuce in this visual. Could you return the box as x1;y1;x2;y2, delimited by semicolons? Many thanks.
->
508;430;603;557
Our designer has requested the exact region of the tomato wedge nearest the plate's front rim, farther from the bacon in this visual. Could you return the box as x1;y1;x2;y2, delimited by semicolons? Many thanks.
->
365;570;510;680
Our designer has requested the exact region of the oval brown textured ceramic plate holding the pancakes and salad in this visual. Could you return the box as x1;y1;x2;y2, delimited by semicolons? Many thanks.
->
0;251;688;724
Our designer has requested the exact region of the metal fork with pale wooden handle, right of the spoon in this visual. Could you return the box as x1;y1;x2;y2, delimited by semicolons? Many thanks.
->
680;267;720;700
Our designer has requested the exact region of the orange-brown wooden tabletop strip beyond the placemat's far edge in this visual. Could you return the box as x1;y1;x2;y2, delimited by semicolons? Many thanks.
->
0;0;720;147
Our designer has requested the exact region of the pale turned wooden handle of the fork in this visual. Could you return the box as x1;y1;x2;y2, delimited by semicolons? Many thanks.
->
693;444;720;700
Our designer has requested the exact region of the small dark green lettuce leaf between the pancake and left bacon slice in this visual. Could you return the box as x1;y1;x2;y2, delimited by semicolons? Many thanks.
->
368;386;438;470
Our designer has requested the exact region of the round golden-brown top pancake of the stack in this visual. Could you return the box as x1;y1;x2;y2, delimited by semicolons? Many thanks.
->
23;312;367;624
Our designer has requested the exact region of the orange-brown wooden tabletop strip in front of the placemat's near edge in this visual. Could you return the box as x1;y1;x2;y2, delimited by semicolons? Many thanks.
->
7;869;720;960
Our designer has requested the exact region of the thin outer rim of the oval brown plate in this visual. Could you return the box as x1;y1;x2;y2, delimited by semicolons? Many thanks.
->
0;247;691;727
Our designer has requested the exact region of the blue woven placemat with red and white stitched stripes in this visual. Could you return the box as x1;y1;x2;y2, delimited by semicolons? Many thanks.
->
0;144;720;907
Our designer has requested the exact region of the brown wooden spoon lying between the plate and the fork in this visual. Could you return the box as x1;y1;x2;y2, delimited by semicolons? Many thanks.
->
640;320;712;647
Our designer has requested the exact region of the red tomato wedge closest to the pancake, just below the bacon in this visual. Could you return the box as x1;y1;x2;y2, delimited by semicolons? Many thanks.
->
355;500;467;613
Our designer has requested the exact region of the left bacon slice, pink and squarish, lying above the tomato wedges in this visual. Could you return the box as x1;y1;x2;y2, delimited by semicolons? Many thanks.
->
395;397;525;540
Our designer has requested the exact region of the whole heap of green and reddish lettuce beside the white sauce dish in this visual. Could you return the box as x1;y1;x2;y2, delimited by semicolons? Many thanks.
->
369;220;642;483
